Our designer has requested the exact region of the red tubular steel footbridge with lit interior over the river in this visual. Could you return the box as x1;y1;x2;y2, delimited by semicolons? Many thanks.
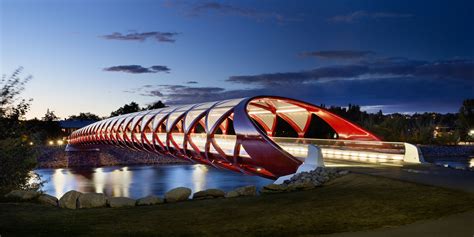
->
66;96;422;179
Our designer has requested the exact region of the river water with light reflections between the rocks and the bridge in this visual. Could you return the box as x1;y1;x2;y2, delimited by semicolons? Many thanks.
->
36;165;273;198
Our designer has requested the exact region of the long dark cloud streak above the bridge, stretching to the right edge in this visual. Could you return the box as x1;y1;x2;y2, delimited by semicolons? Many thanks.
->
227;58;474;86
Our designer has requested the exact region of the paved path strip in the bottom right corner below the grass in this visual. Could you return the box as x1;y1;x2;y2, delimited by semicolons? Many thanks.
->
324;211;474;237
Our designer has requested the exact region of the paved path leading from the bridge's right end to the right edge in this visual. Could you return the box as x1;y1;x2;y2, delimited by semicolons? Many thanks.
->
328;160;474;193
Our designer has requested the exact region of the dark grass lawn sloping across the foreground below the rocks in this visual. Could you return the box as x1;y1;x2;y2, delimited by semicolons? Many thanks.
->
0;174;474;237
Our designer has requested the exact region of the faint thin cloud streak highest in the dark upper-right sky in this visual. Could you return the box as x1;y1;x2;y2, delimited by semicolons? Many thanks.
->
328;11;413;23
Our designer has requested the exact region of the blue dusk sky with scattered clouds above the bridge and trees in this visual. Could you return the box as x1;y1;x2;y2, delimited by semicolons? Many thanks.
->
0;0;474;118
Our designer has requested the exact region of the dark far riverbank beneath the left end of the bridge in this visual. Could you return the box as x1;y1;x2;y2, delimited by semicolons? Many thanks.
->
37;146;189;168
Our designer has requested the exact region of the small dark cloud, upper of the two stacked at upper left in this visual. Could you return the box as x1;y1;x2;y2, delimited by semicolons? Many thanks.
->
102;31;178;43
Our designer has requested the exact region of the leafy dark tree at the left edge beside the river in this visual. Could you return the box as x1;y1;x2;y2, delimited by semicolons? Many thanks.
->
0;67;38;193
